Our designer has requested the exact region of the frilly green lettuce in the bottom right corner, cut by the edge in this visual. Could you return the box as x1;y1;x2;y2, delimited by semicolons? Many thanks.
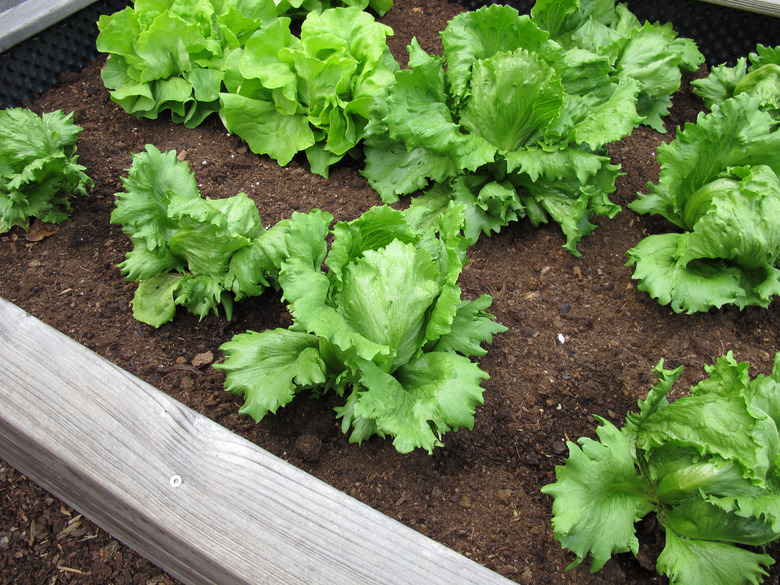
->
542;352;780;585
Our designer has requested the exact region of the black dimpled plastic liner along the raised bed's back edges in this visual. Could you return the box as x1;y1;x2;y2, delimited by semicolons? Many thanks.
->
0;0;780;109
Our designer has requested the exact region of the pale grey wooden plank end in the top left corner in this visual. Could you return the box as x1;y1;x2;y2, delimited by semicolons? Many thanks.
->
0;0;95;53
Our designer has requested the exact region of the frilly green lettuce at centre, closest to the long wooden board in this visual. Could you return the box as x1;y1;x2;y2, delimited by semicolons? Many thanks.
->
214;205;505;452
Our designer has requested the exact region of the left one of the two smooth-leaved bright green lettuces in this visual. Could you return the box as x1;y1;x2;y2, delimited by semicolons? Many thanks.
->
97;0;277;128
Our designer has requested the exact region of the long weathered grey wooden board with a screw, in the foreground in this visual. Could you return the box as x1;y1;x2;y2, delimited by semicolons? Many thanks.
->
0;298;510;585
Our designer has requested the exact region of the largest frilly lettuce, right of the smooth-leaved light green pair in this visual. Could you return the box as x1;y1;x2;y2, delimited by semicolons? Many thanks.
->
363;5;641;254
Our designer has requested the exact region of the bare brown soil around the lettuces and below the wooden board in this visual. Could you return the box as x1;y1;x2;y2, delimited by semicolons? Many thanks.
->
0;0;780;585
